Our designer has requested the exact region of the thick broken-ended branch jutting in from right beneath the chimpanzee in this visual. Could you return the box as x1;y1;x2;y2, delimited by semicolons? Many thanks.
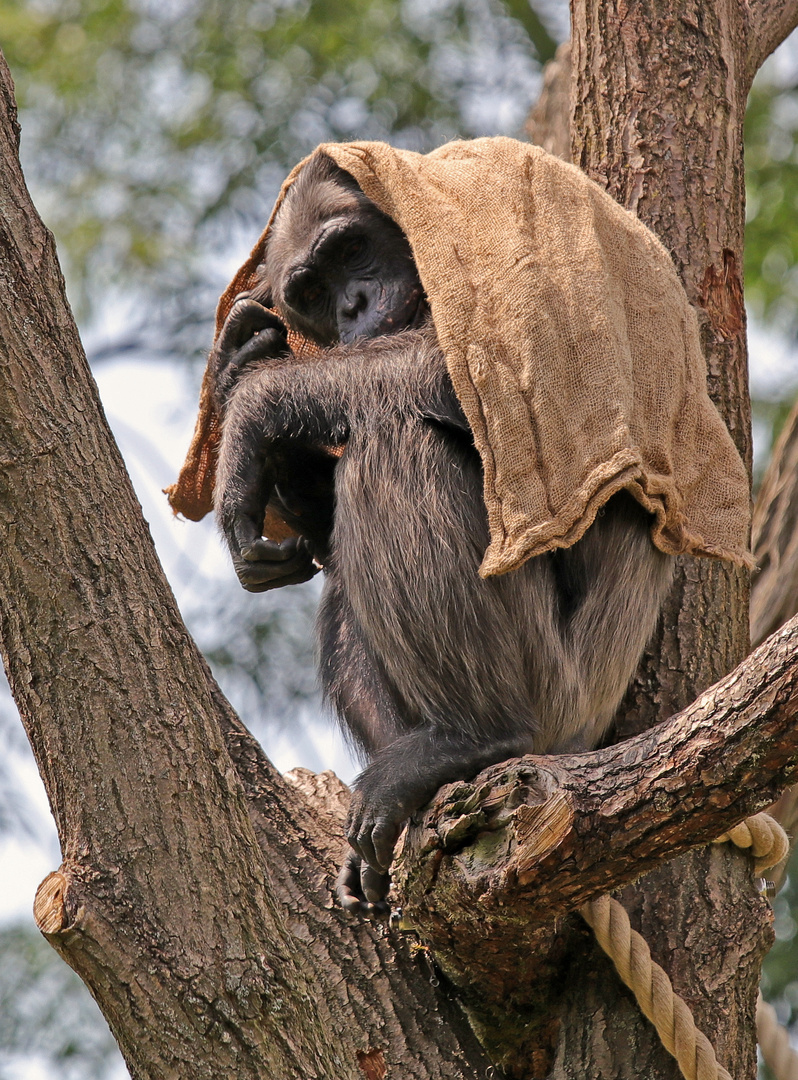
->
396;618;798;1062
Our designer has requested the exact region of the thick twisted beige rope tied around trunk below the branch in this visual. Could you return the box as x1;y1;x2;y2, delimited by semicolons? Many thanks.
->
579;813;798;1080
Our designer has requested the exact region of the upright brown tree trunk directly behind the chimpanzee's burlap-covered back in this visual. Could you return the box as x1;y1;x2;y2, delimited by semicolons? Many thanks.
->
554;0;798;1078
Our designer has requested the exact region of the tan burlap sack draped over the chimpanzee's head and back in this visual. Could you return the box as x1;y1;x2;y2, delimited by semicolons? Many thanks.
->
165;138;752;576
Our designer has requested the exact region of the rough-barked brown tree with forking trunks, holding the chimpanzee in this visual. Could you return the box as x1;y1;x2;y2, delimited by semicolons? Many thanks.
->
0;0;798;1078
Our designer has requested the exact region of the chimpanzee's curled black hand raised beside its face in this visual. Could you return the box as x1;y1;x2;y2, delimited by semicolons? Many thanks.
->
211;293;290;413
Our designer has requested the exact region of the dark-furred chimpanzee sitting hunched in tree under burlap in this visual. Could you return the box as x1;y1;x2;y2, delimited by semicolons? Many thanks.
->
212;154;673;915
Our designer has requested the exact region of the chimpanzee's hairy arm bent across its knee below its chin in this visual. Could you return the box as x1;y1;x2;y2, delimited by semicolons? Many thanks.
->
217;328;471;591
